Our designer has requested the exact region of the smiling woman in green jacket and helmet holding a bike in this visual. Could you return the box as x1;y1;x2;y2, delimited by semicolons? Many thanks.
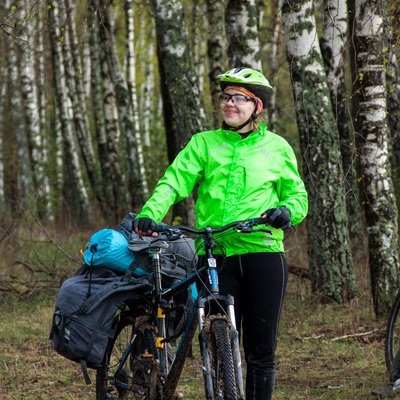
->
134;68;307;400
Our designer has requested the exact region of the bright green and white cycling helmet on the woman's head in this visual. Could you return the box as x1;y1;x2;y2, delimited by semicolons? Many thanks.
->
218;67;273;108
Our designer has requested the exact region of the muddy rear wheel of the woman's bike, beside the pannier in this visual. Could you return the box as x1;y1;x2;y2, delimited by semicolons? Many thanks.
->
96;312;162;400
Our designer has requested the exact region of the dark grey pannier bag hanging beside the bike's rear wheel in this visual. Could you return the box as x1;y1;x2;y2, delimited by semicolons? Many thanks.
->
49;265;152;384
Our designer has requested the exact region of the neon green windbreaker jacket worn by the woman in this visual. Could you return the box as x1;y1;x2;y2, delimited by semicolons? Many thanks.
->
137;123;308;256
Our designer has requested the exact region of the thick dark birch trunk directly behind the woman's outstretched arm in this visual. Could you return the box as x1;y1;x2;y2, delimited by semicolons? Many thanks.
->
151;0;208;225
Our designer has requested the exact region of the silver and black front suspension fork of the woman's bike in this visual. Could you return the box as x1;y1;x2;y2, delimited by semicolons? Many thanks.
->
197;294;244;400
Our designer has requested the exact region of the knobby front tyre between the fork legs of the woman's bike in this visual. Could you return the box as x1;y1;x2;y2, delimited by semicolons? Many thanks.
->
208;319;238;400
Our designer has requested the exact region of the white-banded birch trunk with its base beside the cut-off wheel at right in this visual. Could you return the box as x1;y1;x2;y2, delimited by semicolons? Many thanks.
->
354;0;399;315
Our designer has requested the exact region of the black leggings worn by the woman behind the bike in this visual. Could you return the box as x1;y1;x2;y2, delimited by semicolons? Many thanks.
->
219;253;288;400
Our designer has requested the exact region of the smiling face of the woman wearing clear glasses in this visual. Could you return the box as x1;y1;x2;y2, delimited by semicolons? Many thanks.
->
220;89;256;132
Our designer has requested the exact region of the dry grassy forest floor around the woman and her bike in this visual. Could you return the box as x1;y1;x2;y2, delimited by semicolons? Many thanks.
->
0;225;400;400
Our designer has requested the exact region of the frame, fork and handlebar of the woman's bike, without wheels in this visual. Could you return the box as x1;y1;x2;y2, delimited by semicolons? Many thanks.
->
107;219;269;400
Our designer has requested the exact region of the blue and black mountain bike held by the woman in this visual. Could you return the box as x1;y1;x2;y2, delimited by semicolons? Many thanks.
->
96;218;271;400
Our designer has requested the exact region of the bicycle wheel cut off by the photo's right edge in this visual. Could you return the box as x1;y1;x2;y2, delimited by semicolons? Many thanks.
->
385;292;400;382
